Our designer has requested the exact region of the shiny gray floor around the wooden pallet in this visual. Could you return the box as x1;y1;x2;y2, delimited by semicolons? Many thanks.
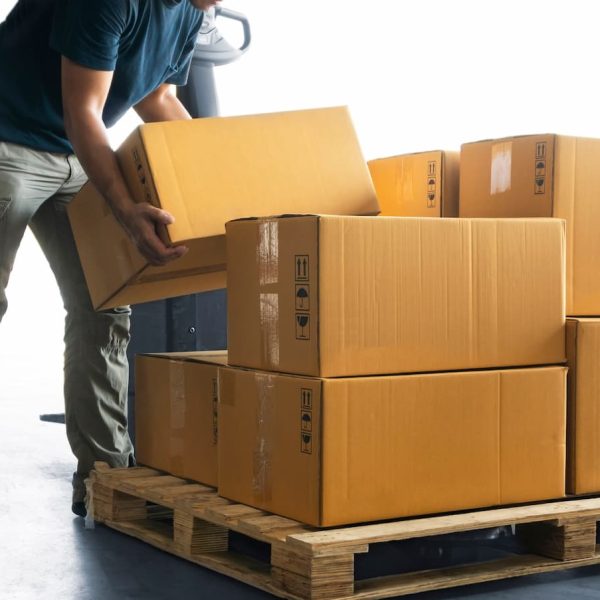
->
0;394;600;600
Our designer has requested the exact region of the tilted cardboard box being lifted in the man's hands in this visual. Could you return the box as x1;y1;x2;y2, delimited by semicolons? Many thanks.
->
69;107;379;309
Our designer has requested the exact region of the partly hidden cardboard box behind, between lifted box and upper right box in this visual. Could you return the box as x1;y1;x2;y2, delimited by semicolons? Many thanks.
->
367;150;460;217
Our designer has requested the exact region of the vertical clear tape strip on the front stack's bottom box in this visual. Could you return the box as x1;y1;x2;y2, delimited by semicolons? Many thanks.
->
252;373;275;502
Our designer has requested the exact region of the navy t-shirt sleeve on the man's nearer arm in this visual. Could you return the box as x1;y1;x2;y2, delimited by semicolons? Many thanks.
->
50;0;130;71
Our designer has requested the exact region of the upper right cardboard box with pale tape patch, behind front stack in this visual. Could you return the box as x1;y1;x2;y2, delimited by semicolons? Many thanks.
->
459;135;600;316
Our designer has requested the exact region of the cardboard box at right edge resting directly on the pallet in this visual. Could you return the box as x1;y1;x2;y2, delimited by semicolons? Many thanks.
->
567;319;600;494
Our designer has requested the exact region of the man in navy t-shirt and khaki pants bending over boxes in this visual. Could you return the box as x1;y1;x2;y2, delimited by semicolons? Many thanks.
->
0;0;220;516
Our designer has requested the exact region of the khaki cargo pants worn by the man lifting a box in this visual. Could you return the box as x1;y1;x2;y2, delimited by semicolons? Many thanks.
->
0;142;133;501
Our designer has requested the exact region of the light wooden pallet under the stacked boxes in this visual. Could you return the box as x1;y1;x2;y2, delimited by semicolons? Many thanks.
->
89;463;600;600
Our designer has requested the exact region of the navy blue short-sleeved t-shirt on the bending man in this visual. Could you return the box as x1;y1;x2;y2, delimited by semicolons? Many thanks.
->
0;0;203;152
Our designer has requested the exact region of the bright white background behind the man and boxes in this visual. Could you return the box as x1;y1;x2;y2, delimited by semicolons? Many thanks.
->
0;0;600;412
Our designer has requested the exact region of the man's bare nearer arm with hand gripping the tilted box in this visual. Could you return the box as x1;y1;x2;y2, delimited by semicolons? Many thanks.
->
62;56;189;265
